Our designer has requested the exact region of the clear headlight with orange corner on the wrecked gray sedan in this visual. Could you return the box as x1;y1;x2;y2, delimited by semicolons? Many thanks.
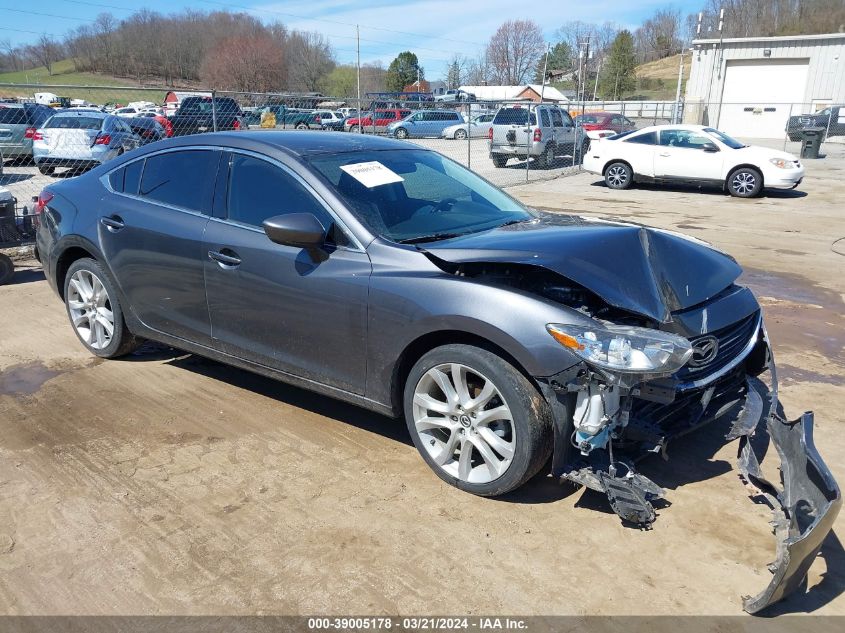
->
546;323;692;374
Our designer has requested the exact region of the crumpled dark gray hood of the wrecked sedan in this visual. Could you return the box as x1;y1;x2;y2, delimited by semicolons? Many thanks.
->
421;214;742;323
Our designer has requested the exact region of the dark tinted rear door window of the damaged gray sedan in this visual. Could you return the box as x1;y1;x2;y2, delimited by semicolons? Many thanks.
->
140;150;219;215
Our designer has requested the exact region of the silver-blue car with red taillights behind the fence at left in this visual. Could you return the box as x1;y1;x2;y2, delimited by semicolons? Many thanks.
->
32;109;141;175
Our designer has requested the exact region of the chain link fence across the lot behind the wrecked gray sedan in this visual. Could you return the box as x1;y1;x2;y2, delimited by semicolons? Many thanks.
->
0;84;845;225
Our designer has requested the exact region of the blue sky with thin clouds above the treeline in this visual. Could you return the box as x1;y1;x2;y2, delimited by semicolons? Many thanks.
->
0;0;688;79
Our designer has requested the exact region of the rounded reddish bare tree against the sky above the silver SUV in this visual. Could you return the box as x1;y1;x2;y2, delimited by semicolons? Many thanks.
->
487;20;546;86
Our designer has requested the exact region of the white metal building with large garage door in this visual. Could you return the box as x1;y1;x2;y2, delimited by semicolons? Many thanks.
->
684;33;845;138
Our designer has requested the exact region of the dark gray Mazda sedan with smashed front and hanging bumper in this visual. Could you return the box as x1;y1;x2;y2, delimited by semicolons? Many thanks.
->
33;132;841;611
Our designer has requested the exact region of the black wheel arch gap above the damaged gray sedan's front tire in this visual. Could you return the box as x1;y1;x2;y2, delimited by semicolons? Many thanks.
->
390;329;542;416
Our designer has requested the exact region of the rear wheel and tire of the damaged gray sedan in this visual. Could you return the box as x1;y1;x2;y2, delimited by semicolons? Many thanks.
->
64;258;143;358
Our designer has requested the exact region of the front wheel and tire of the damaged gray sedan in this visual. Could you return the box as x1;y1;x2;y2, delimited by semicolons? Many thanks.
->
404;345;553;497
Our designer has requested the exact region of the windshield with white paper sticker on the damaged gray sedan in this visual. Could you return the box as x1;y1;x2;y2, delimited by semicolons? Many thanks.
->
309;150;534;243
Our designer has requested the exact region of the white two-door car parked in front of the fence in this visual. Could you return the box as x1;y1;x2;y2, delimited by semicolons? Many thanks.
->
584;125;804;198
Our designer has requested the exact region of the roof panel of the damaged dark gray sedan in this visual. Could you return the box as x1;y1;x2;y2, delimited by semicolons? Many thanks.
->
150;130;420;158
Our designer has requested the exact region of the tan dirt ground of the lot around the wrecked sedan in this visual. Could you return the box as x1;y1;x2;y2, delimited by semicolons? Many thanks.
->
0;142;845;614
